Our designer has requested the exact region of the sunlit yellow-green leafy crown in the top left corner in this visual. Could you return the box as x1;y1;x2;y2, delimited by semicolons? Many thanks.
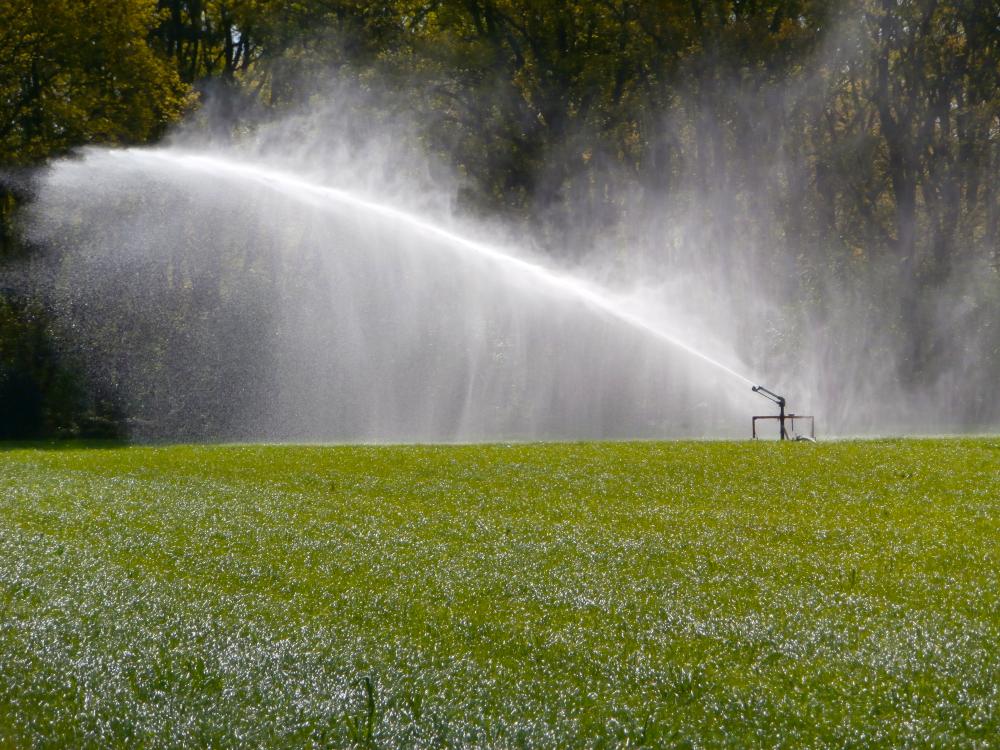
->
0;0;189;165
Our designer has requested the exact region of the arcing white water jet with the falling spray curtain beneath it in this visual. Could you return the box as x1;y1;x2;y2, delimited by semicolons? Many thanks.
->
32;148;768;442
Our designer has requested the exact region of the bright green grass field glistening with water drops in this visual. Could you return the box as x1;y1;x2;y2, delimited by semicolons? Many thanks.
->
0;438;1000;747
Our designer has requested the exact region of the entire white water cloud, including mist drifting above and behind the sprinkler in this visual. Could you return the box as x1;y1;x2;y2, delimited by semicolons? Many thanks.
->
24;69;1000;441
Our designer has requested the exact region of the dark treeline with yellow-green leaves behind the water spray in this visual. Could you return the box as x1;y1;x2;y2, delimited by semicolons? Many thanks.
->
0;0;1000;438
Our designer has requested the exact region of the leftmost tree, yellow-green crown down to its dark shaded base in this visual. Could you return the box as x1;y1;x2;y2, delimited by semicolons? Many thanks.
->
0;0;191;437
